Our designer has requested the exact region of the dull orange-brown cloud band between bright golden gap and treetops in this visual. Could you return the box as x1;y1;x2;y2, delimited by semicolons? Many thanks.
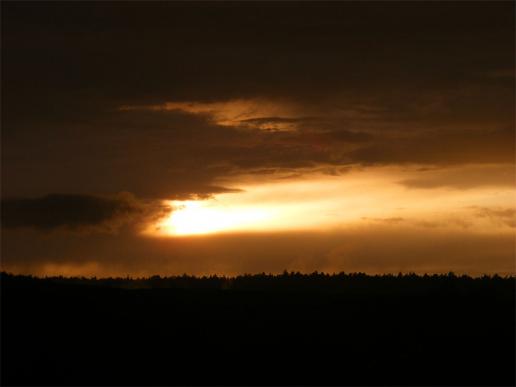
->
2;227;516;276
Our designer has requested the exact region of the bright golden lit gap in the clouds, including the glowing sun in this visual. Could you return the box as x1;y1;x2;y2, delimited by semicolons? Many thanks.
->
145;168;515;237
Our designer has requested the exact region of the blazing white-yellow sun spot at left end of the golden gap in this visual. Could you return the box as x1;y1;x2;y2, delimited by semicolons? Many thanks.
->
158;200;268;236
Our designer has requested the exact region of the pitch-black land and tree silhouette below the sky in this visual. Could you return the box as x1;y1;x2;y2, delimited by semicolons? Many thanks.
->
1;274;515;385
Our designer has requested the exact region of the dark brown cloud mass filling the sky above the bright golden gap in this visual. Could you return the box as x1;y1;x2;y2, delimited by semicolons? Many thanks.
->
2;2;514;198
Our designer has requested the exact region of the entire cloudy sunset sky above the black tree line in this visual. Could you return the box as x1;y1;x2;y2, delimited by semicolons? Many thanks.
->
0;1;516;276
